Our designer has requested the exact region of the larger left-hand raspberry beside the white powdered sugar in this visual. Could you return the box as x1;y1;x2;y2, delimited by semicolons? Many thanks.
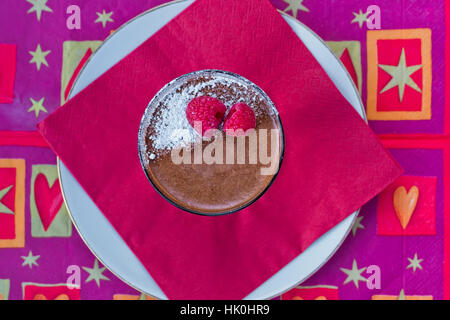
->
186;96;227;136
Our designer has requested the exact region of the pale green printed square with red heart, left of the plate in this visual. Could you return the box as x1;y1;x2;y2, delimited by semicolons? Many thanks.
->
30;165;72;238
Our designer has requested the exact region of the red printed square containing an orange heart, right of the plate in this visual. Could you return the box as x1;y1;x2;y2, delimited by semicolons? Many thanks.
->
377;176;437;236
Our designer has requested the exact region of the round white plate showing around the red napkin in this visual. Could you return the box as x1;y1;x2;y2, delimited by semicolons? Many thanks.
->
58;0;365;299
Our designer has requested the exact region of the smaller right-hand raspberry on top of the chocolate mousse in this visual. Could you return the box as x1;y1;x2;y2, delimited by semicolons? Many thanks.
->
223;102;256;136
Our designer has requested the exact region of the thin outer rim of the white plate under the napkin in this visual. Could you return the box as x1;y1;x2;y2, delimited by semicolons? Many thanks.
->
56;0;368;300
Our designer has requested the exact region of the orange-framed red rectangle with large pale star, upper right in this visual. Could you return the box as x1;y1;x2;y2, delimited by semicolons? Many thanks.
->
367;29;432;120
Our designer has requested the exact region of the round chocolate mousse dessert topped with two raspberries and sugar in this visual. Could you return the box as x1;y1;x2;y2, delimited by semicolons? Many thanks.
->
138;70;284;215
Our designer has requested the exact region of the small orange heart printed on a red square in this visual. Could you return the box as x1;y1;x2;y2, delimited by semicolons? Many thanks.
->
394;186;419;229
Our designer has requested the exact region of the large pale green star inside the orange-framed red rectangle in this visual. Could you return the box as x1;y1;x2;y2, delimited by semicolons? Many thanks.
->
378;48;422;102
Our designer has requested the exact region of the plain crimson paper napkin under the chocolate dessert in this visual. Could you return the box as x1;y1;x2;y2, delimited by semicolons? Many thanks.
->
39;0;401;299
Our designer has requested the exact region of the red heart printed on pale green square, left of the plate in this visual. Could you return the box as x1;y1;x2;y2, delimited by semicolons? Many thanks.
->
34;173;63;231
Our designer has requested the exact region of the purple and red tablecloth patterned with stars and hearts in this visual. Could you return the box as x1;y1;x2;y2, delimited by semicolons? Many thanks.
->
0;0;450;300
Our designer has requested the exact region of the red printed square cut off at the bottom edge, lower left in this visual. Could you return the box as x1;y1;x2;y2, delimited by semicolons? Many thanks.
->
22;282;80;300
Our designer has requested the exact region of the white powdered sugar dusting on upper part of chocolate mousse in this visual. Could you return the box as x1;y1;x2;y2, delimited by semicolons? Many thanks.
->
139;70;277;162
